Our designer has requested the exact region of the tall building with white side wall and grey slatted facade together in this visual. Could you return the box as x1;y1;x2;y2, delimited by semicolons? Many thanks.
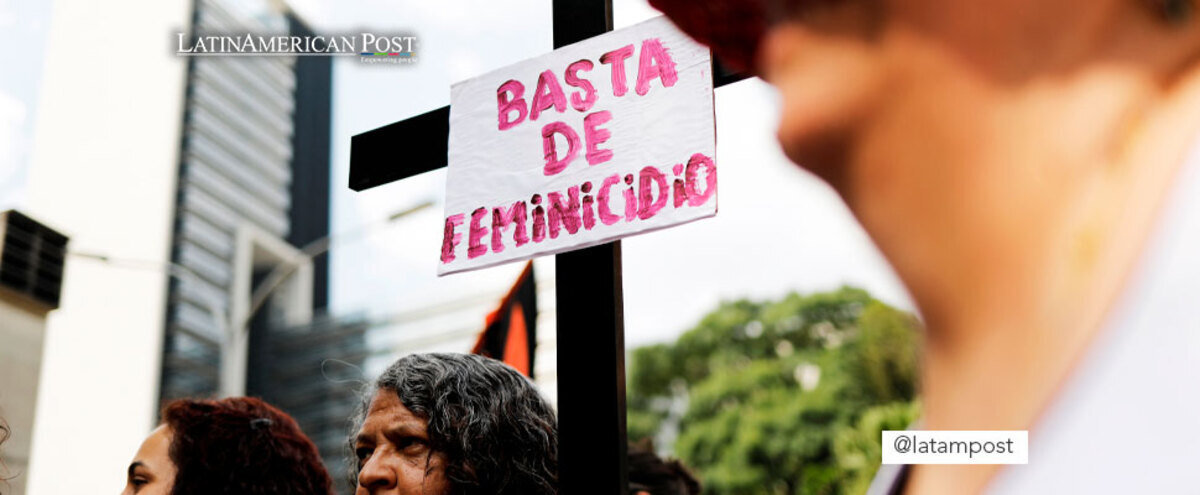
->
23;0;350;495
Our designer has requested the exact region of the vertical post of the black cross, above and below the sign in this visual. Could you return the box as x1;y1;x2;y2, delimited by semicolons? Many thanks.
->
552;0;629;495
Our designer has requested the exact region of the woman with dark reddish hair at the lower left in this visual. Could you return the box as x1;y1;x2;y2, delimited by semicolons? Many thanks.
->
122;398;332;495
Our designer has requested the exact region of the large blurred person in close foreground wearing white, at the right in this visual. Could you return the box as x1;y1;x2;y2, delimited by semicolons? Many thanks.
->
650;0;1200;494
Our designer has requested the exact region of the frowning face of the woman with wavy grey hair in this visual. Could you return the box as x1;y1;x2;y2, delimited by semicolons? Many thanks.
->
354;389;450;495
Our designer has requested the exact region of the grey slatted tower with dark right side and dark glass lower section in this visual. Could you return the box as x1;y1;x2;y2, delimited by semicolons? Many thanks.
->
160;0;366;480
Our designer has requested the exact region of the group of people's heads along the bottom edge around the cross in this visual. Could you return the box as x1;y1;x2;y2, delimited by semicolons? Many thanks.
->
105;353;700;495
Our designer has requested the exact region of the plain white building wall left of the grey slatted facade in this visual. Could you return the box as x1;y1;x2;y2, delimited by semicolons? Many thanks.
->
26;0;191;495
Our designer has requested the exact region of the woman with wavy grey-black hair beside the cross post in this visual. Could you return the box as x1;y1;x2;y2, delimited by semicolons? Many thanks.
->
350;353;558;495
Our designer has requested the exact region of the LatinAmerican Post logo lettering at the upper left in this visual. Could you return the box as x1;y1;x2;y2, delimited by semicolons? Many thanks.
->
175;32;418;64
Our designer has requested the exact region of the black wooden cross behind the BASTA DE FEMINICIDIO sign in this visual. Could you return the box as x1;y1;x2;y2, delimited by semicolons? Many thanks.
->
350;0;745;495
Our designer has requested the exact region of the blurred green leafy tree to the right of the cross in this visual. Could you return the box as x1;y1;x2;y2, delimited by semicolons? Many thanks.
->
628;288;919;494
